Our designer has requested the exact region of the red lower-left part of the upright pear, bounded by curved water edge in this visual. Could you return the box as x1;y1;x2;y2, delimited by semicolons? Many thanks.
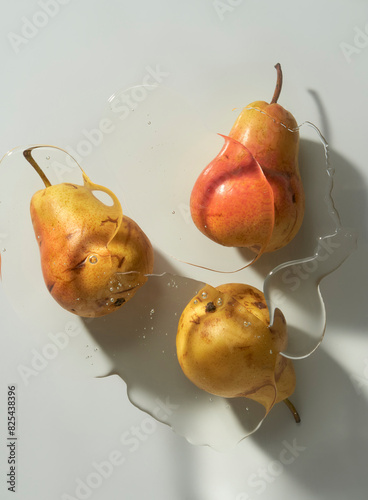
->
190;136;274;254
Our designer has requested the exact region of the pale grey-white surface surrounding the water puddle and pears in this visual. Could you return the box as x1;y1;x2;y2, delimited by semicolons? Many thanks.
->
0;0;368;500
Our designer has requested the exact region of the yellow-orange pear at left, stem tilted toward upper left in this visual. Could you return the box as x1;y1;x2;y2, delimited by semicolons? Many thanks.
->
24;149;153;317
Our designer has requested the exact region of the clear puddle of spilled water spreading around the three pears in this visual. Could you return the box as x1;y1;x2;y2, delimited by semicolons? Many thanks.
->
0;87;356;449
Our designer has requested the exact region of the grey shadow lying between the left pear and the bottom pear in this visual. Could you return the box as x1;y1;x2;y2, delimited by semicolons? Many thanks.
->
84;247;204;406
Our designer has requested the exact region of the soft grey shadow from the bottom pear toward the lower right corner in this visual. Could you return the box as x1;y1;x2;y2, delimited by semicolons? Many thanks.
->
240;345;368;500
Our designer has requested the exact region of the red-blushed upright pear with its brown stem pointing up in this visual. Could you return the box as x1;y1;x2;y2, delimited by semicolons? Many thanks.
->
190;64;305;255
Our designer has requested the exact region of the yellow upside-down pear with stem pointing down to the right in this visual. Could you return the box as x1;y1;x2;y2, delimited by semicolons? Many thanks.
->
176;283;300;421
